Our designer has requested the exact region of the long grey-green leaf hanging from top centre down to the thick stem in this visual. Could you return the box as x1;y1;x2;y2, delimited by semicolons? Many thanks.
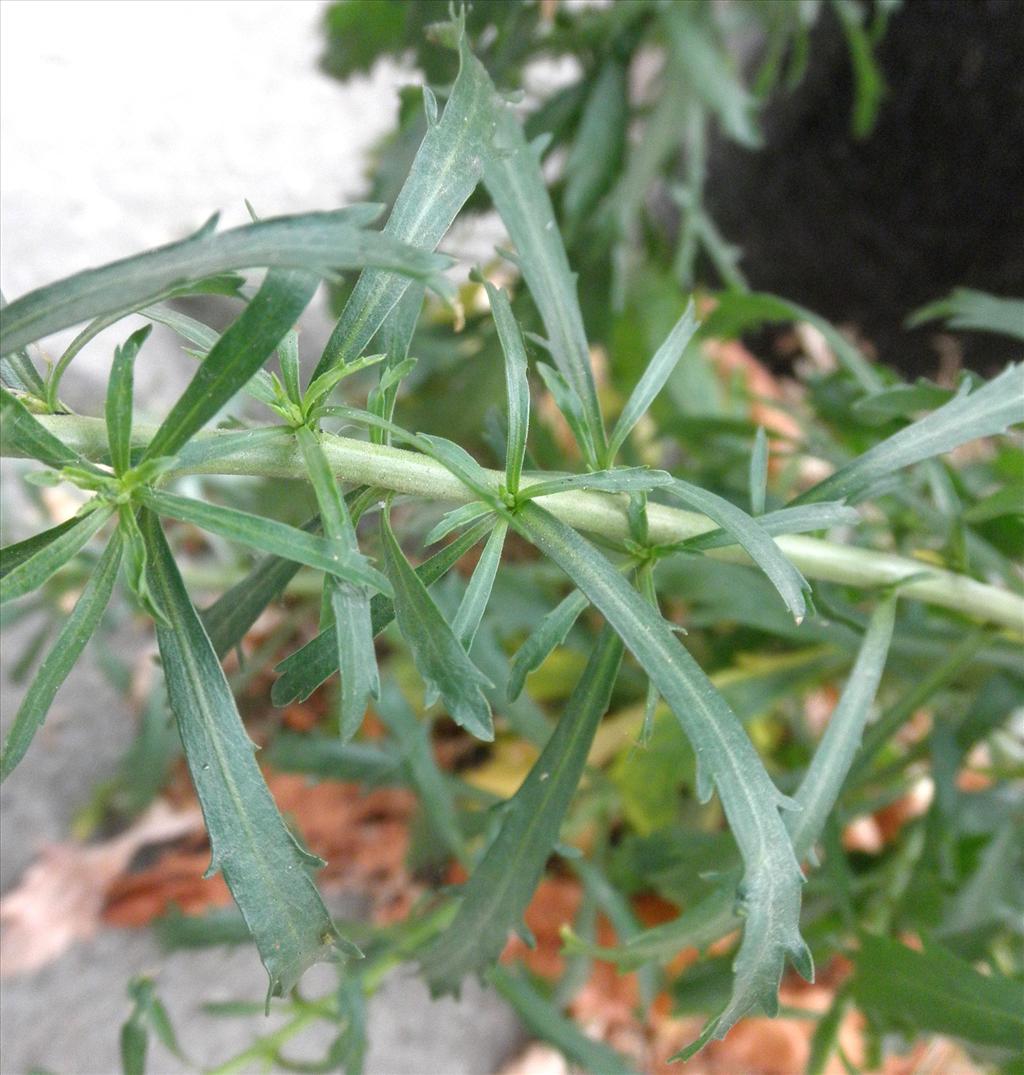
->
479;41;605;467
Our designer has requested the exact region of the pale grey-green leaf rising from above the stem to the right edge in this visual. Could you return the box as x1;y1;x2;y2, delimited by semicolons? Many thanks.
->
794;364;1024;503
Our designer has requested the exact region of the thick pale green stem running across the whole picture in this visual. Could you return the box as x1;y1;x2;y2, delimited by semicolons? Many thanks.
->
10;415;1024;631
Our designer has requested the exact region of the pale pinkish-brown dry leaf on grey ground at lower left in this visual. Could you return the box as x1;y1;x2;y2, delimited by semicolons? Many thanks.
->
0;801;202;975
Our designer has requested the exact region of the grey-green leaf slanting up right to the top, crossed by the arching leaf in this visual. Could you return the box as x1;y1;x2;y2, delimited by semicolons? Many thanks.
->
314;32;490;376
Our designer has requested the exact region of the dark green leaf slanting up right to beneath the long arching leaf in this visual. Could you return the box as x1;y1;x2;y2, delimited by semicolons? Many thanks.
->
144;269;318;459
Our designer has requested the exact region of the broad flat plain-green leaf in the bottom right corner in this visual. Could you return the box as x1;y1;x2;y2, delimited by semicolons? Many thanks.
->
852;934;1024;1051
